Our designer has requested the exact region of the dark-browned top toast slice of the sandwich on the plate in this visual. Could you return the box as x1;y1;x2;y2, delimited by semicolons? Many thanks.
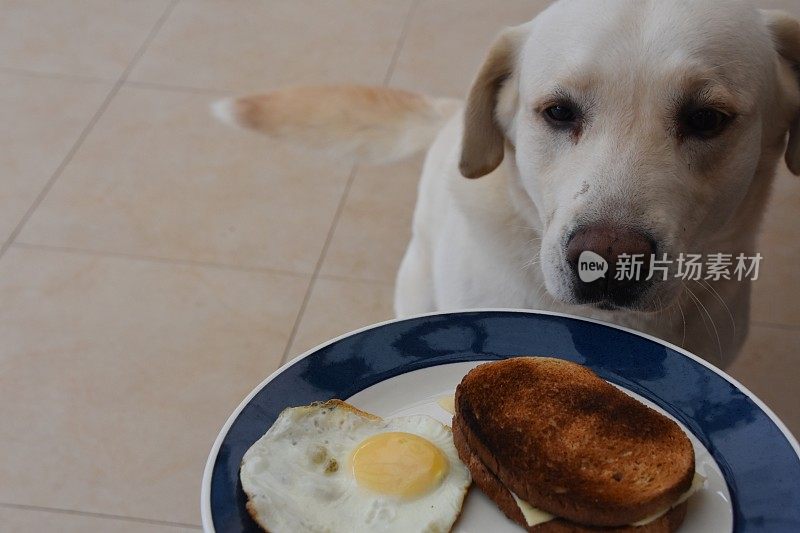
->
453;357;694;531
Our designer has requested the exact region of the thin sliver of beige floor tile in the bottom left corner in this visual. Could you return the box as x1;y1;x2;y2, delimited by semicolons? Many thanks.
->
0;507;197;533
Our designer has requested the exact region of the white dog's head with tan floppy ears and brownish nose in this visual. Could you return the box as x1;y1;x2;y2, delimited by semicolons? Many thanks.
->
460;0;800;310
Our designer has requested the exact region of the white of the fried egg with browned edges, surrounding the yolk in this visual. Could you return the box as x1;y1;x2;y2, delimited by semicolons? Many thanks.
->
240;403;471;533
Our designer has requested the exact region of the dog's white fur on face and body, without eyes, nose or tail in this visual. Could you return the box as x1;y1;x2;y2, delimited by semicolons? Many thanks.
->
395;0;798;364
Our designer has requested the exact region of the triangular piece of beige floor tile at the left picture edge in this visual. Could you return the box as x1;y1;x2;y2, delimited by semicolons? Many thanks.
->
0;72;111;243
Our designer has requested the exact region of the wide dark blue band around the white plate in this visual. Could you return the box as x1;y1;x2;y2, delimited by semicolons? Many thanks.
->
210;311;800;533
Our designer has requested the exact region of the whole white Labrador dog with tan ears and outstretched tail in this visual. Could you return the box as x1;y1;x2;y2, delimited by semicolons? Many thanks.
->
215;0;800;364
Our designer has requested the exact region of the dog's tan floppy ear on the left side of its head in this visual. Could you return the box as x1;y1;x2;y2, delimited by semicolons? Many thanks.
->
458;26;527;178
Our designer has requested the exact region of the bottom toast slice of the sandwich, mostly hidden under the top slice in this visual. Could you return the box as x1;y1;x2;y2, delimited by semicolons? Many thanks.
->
453;424;687;533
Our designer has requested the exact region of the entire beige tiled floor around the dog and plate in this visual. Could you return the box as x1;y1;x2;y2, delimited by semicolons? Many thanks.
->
0;0;800;532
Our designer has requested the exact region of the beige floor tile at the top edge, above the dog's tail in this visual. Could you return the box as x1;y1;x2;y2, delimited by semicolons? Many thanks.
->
131;0;410;91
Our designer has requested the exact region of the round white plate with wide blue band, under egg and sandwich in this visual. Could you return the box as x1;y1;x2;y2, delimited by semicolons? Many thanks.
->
201;310;800;533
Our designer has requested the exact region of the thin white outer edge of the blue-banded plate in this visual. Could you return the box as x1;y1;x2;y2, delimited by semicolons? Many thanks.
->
200;307;800;533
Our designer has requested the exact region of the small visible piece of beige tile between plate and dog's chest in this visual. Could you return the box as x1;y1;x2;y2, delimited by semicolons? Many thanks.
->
289;279;394;357
